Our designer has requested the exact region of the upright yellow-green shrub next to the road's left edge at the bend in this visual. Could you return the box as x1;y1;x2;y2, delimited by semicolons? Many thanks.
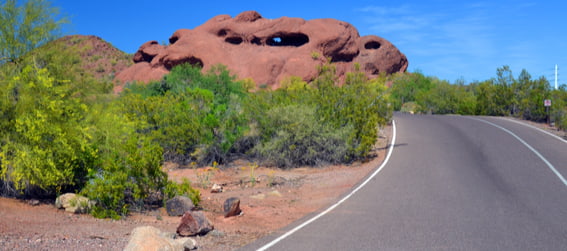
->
313;65;392;160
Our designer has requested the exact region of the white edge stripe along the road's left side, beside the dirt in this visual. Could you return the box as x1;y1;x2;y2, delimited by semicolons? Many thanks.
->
257;120;396;251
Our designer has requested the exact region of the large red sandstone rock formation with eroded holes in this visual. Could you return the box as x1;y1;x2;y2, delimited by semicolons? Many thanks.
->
116;11;408;89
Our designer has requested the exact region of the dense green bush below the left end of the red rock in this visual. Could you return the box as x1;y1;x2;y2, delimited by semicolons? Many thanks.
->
124;64;250;165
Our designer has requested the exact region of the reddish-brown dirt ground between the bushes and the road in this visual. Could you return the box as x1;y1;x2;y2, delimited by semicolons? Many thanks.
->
0;127;391;250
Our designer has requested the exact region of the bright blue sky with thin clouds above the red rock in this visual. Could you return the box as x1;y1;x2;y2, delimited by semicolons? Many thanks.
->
52;0;567;84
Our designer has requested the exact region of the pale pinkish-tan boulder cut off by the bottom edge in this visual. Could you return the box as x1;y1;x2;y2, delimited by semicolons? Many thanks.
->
124;226;196;251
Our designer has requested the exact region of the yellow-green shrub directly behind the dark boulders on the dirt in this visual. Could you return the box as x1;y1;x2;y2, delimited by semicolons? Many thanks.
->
81;101;199;218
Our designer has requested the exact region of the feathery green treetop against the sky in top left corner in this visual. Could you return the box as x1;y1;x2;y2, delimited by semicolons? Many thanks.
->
0;0;67;64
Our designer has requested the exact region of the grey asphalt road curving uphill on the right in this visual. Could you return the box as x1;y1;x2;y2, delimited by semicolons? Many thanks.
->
243;115;567;250
